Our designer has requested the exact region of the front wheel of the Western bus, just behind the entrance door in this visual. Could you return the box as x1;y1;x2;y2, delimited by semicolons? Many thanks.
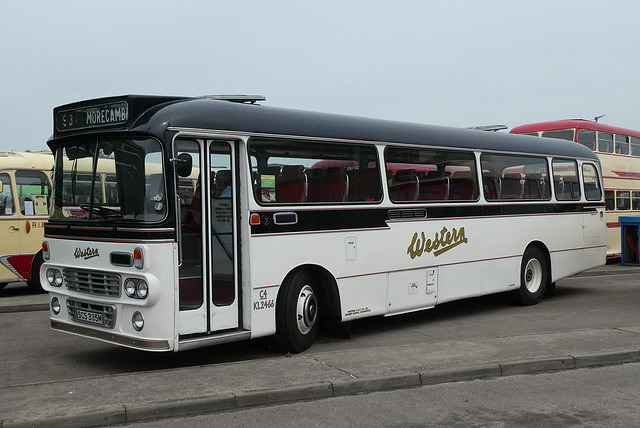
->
276;270;320;353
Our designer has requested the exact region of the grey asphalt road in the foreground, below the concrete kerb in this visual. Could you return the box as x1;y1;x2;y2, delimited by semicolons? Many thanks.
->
127;364;640;428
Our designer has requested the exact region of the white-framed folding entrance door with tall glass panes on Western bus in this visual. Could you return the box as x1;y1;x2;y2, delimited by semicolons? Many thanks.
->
176;139;238;336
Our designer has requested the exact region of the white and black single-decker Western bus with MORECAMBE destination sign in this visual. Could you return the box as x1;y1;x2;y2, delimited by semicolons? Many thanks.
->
41;96;606;352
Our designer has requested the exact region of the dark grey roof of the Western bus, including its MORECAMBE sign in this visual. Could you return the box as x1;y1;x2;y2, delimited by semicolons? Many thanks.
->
48;95;598;160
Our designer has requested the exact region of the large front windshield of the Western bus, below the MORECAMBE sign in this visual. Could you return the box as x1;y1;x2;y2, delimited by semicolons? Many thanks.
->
51;138;167;222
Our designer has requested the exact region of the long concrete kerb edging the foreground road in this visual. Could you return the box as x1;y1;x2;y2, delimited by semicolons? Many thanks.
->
0;350;640;428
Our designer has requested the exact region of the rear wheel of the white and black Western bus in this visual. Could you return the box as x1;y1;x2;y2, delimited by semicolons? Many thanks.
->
515;247;549;306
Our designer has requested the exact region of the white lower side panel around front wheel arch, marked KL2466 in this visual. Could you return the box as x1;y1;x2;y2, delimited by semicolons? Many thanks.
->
245;230;388;337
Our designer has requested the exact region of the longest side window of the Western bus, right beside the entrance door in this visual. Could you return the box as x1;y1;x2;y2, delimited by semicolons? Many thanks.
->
249;139;382;204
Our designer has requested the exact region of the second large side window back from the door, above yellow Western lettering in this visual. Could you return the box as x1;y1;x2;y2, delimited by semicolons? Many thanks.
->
385;147;479;202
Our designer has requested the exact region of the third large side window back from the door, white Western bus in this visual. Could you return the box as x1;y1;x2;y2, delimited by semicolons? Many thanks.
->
480;153;551;201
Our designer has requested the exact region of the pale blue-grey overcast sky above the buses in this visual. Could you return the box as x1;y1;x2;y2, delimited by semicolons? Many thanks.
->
0;0;640;151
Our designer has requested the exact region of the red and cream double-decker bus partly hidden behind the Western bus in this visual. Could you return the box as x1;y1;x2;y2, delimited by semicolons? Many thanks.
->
510;119;640;258
